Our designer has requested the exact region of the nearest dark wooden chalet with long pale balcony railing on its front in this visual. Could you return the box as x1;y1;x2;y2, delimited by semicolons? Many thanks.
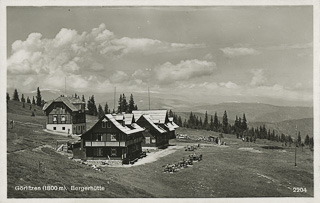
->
73;114;144;161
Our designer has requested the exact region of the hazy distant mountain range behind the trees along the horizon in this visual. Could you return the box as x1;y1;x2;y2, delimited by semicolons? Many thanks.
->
8;90;313;137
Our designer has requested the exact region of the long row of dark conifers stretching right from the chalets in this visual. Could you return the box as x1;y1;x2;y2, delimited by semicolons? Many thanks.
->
169;110;314;149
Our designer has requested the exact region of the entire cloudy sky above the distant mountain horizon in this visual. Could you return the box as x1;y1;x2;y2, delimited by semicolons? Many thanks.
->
7;6;313;106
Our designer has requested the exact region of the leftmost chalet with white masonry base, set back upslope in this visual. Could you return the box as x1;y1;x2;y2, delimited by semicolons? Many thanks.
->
43;96;86;134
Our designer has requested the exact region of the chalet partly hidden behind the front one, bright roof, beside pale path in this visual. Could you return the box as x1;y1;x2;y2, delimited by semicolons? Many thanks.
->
132;110;179;148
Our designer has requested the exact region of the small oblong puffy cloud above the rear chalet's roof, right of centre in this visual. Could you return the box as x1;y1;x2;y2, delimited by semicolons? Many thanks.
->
154;59;216;84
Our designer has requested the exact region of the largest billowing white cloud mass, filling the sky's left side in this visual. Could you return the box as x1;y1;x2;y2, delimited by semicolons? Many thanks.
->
7;24;205;89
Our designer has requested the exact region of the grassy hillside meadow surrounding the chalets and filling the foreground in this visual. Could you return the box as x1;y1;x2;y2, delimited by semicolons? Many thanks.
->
7;101;314;198
